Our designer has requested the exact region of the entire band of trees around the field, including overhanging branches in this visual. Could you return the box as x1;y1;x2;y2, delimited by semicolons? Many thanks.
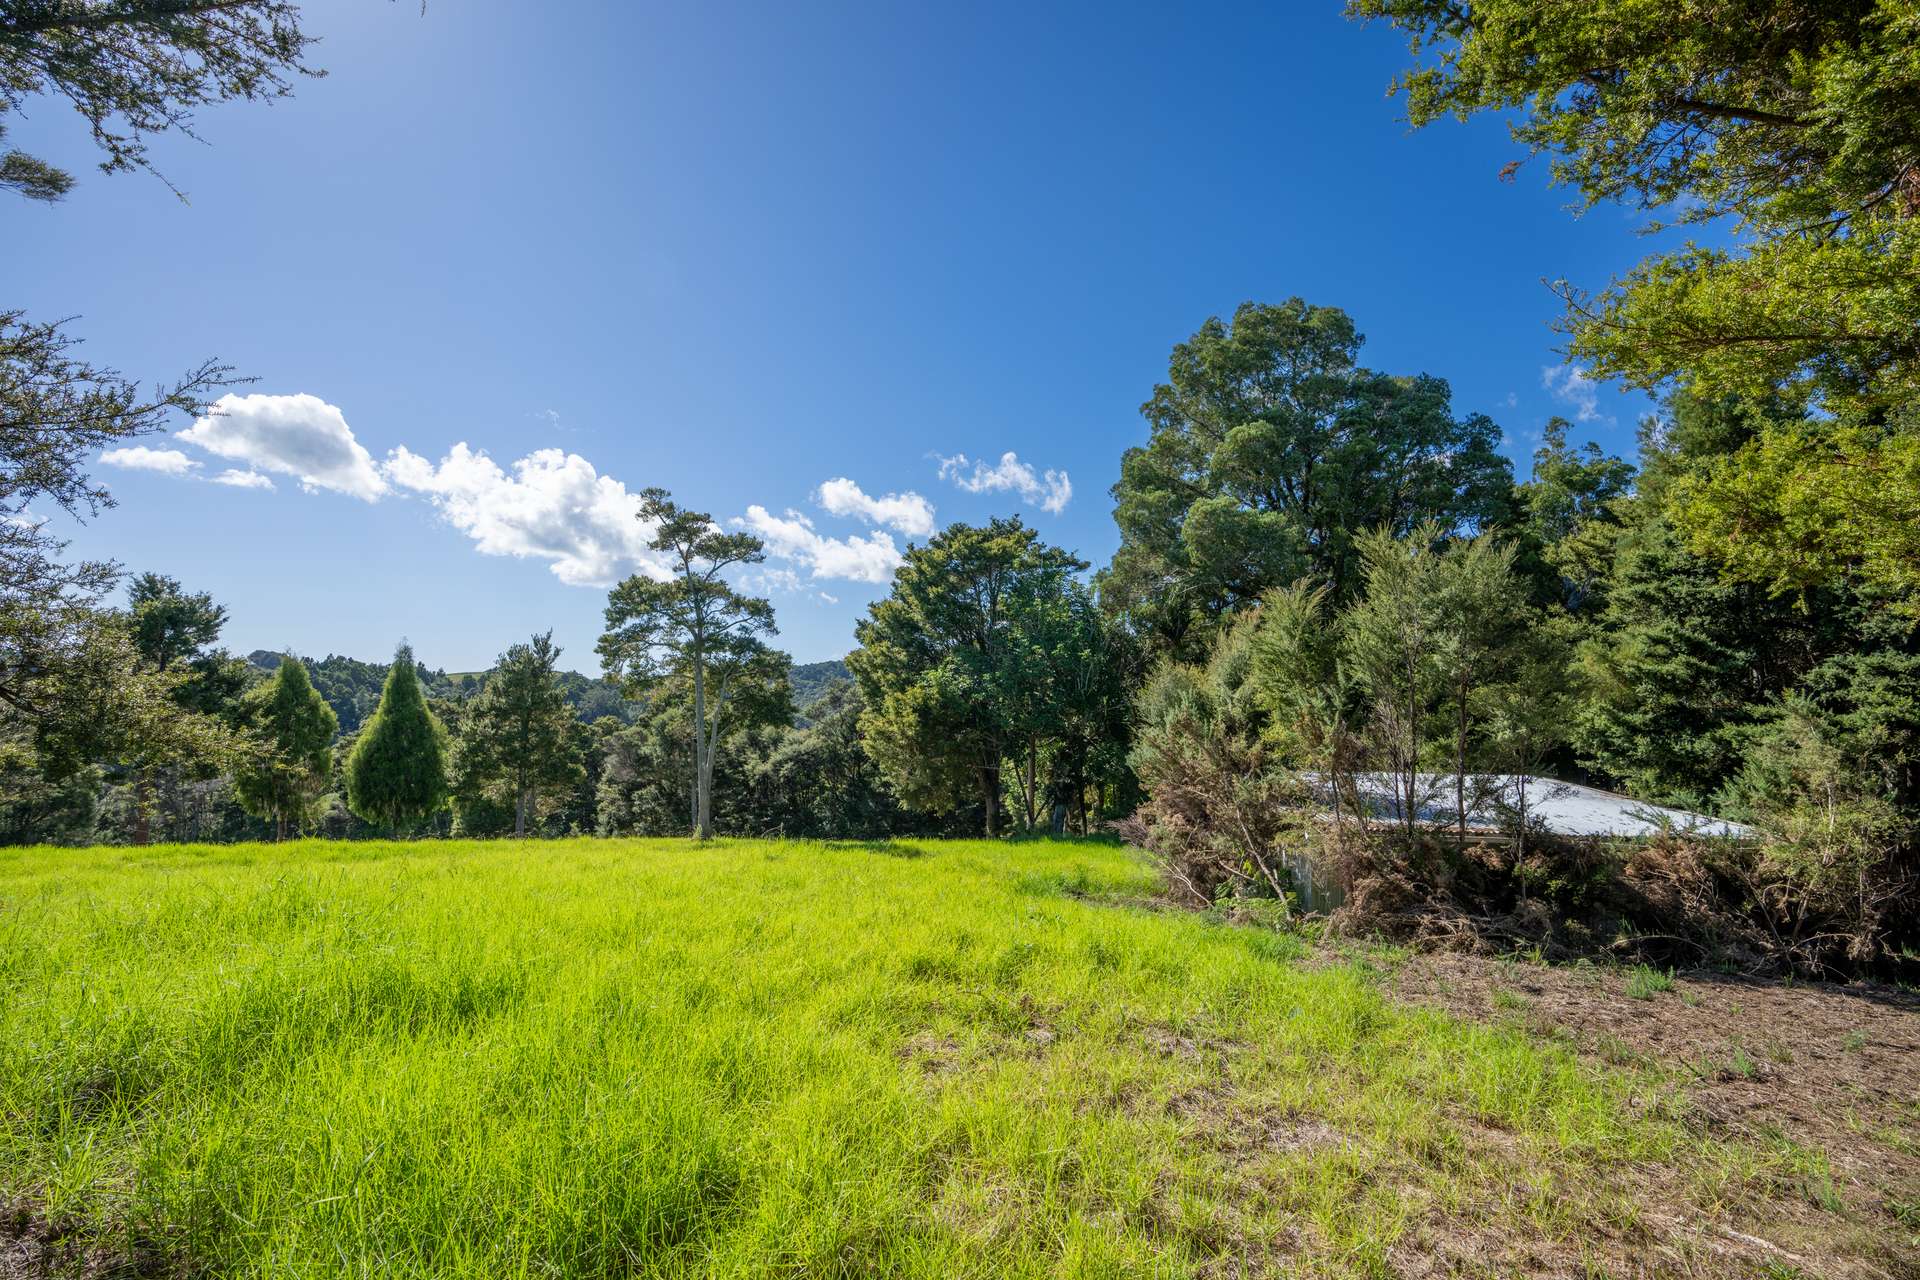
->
0;0;1920;969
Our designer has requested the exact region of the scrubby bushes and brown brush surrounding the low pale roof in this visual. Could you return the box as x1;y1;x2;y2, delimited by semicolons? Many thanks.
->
1125;510;1920;975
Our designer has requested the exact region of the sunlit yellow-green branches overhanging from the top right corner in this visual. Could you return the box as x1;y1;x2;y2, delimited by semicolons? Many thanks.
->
1348;0;1920;403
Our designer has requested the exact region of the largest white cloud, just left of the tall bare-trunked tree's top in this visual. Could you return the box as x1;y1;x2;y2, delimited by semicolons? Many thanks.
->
382;441;666;587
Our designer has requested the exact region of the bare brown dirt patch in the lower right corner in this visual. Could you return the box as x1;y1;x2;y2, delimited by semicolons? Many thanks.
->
1386;954;1920;1278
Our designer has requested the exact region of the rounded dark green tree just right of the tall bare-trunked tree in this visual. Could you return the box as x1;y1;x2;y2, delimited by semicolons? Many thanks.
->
847;518;1087;837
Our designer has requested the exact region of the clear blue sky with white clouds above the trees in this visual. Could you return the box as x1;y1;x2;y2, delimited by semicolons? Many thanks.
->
15;0;1647;670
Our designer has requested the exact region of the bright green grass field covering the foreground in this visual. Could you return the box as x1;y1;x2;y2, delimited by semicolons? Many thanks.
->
0;841;1820;1278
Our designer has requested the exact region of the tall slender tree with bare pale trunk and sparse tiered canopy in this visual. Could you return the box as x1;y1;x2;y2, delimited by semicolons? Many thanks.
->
599;489;791;841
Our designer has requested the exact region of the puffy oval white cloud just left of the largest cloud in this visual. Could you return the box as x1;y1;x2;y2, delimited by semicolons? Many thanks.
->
175;395;386;503
